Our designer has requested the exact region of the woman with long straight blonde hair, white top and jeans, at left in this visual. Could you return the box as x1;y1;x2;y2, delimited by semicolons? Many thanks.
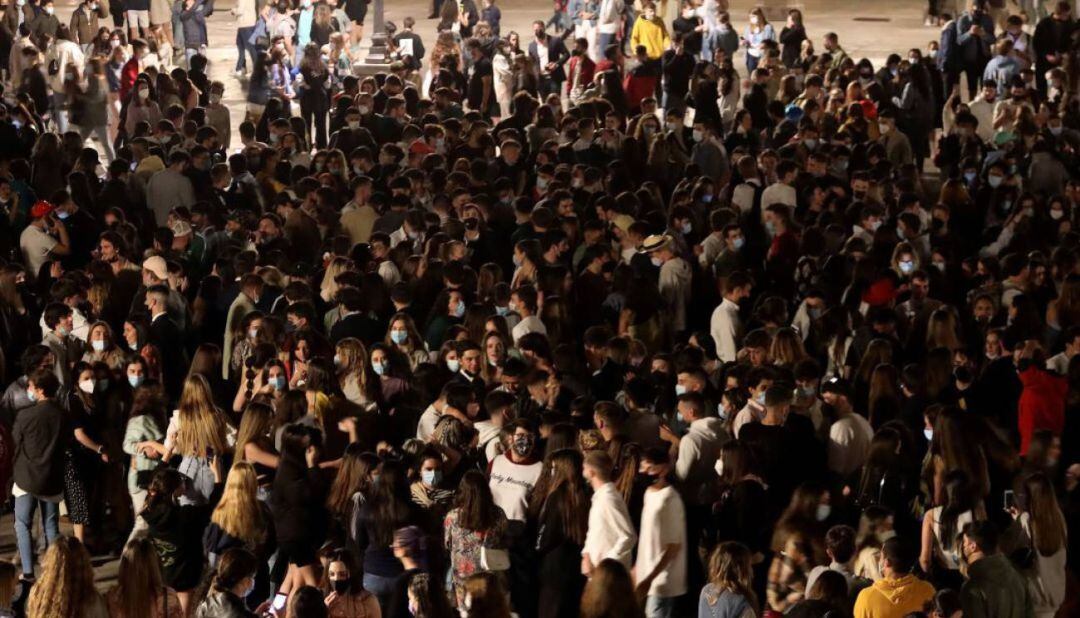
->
162;374;237;505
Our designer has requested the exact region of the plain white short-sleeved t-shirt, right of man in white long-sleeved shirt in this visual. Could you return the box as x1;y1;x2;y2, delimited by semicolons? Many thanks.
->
635;485;686;597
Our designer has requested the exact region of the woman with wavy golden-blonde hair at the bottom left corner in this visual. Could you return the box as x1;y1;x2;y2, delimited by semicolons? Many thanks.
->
26;536;109;618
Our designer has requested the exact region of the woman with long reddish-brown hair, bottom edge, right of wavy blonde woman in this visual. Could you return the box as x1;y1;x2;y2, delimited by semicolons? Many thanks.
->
105;538;184;618
